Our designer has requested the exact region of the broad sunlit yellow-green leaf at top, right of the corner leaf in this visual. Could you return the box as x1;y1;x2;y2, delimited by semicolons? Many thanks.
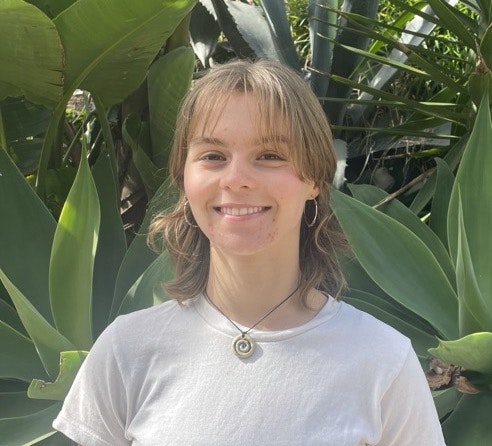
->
54;0;195;105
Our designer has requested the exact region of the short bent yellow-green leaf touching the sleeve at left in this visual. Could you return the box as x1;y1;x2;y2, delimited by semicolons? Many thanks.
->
27;351;89;401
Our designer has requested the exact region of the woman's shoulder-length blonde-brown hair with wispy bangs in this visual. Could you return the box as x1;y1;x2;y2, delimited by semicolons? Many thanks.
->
149;60;346;301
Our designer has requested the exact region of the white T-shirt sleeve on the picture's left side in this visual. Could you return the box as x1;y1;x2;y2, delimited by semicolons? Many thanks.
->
53;321;131;446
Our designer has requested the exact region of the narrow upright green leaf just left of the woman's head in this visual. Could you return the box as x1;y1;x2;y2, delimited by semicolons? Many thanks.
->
147;47;195;169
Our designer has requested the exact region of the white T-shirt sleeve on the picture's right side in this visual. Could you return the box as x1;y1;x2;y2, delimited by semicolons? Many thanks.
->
378;348;445;446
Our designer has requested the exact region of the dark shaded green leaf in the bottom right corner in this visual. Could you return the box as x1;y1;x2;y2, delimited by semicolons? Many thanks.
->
443;392;492;446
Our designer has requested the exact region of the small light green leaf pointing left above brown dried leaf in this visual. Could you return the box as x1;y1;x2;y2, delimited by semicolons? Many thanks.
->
429;332;492;373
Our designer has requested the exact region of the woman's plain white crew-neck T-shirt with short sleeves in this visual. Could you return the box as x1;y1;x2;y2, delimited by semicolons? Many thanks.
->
53;297;444;446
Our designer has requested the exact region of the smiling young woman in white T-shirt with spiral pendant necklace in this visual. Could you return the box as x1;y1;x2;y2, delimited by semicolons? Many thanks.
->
54;61;444;446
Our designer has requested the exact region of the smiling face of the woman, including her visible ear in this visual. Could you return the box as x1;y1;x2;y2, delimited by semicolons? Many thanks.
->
184;94;318;255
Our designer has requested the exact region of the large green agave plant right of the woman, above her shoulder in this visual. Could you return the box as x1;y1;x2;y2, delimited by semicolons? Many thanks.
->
332;95;492;446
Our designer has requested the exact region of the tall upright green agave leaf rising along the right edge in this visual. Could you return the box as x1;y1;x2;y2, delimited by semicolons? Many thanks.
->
448;96;492;314
